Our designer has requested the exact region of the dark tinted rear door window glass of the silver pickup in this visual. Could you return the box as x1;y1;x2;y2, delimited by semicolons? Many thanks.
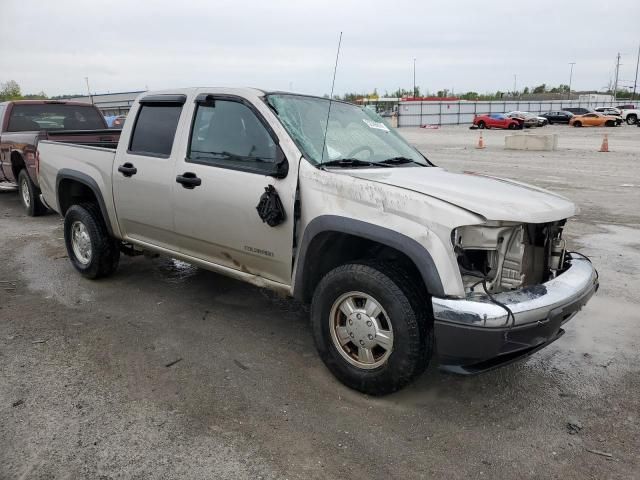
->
129;103;182;157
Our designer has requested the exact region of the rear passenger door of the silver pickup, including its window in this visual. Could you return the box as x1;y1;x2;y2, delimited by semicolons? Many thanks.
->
112;95;186;251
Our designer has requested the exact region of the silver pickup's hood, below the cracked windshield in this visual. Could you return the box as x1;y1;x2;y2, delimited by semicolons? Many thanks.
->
345;167;578;223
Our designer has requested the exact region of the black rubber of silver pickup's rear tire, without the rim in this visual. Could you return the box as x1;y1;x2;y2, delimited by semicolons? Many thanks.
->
64;203;120;279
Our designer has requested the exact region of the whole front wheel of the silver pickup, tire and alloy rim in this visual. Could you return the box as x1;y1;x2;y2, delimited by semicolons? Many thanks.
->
311;263;433;395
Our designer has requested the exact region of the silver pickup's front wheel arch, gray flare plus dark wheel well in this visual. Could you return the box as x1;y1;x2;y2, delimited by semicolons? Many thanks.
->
293;215;444;302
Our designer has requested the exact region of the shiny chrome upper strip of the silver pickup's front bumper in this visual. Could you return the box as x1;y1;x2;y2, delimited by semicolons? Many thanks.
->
432;256;599;329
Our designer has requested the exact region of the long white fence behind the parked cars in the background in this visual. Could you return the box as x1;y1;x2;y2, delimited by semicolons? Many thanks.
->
398;99;633;127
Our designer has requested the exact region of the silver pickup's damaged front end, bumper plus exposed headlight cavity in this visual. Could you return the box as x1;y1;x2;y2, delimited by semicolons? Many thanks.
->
432;220;599;374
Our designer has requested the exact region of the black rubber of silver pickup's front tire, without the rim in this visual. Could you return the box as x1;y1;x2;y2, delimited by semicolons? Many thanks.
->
311;262;434;395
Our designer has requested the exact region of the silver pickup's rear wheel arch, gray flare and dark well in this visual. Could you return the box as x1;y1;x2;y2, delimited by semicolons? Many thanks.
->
56;169;114;236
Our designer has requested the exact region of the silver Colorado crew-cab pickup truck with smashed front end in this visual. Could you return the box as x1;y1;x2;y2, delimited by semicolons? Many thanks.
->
38;88;598;395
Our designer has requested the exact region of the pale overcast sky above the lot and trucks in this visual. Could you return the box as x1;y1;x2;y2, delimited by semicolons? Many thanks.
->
0;0;640;95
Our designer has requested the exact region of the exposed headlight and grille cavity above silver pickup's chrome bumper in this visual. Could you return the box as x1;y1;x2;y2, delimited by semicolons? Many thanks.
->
451;220;565;295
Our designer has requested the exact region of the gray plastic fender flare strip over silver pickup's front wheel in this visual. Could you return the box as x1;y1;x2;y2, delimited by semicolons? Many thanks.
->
293;215;444;299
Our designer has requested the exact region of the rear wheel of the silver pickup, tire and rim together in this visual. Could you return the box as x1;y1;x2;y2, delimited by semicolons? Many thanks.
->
64;204;120;279
